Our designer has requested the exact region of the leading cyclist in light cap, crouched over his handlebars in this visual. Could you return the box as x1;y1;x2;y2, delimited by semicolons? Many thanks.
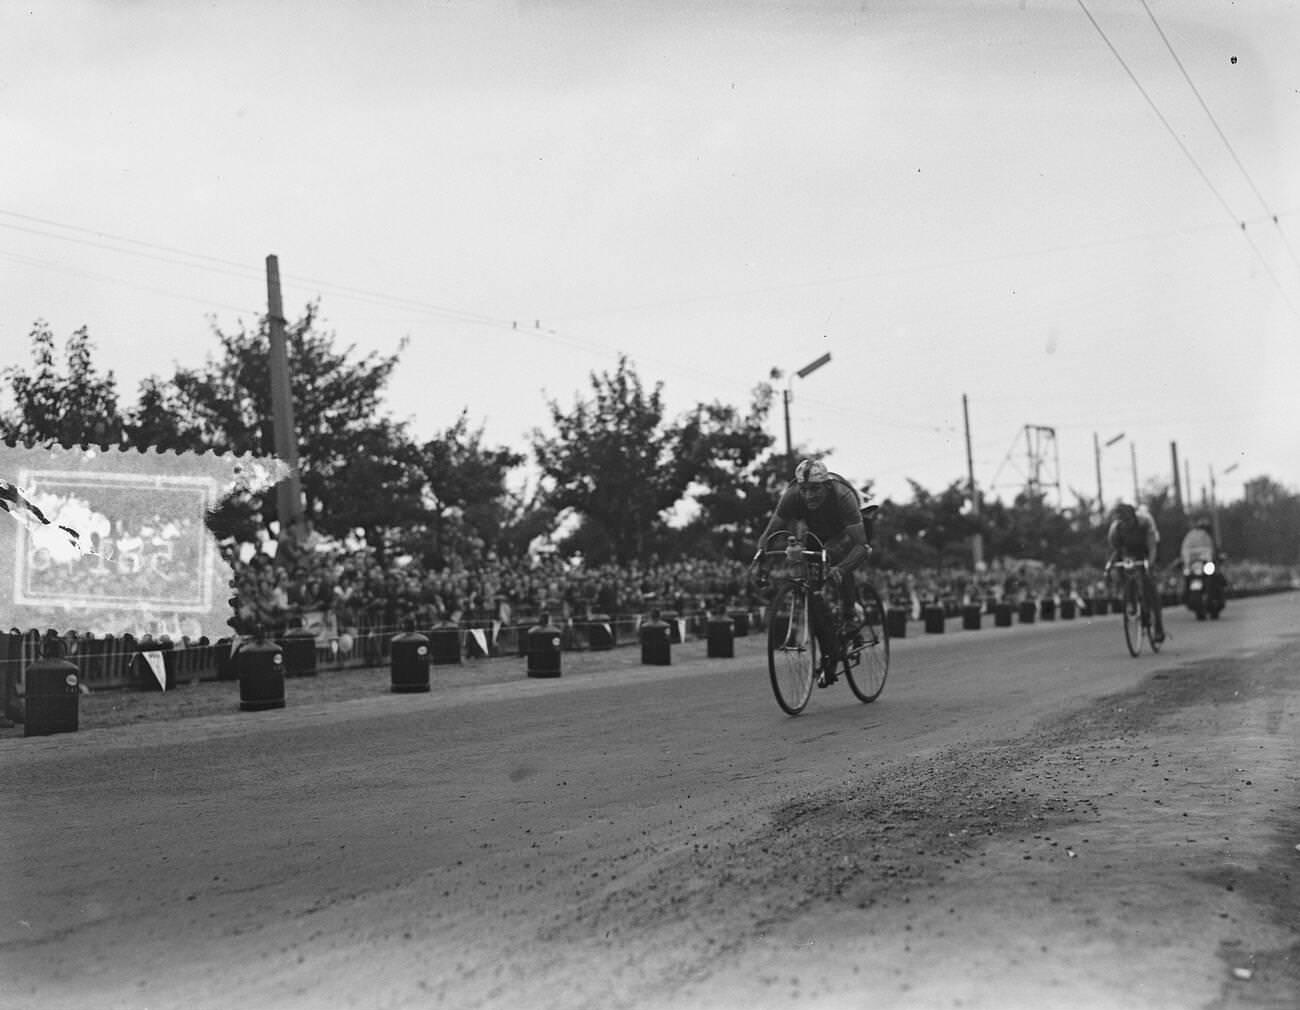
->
750;459;871;688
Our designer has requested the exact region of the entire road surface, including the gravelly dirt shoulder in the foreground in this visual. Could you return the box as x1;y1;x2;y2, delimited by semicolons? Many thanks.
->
0;594;1300;1010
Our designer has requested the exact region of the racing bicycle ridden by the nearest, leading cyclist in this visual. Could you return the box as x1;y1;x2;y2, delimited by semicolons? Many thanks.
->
762;532;889;715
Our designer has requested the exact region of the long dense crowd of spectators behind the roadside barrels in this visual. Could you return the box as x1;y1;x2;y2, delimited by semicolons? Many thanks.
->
234;535;1296;634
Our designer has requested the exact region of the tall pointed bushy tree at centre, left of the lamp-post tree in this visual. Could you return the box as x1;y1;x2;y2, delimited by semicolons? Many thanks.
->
533;356;699;562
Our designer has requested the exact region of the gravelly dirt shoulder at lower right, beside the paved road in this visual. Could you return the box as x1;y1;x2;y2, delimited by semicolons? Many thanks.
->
616;640;1300;1010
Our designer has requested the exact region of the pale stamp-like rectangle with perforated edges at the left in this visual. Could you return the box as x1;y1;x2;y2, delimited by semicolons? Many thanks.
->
0;443;274;640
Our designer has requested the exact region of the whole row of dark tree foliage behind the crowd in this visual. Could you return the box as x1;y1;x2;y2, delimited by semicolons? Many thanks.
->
0;314;1300;568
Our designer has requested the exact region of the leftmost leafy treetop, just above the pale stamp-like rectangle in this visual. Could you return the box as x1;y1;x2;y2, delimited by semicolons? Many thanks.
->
0;320;122;446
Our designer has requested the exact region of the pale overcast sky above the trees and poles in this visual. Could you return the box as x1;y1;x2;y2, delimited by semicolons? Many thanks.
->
0;0;1300;503
